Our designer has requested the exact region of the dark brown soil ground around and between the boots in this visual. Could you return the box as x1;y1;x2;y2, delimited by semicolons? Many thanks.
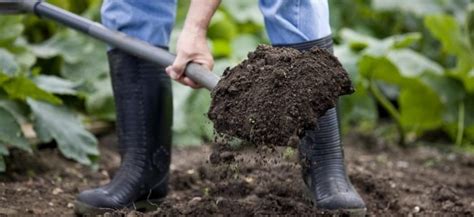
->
0;134;474;216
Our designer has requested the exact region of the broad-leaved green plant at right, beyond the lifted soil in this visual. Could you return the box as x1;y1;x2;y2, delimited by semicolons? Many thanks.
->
336;5;474;145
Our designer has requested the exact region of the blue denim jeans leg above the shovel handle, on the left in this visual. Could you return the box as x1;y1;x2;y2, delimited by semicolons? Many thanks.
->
101;0;177;47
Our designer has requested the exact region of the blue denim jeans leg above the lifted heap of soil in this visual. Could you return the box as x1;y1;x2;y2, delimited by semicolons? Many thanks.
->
259;0;331;45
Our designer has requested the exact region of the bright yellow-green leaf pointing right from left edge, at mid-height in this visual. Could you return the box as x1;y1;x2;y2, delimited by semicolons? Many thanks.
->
2;76;62;104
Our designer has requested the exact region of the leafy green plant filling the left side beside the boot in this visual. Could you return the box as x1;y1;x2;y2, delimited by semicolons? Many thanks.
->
0;8;106;172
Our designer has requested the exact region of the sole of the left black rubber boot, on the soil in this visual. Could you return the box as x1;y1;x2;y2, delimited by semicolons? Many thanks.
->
74;199;163;216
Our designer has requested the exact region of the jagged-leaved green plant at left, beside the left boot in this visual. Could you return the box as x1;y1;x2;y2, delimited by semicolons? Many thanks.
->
0;16;98;172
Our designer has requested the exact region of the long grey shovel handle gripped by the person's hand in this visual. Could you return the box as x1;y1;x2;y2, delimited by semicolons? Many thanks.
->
0;0;219;90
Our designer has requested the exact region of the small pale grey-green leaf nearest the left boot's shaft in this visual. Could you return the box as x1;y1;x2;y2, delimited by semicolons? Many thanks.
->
33;75;77;95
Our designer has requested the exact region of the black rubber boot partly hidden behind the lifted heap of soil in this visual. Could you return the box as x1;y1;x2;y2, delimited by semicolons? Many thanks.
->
278;36;366;216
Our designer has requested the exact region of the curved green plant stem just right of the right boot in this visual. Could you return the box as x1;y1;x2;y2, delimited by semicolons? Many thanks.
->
369;79;406;147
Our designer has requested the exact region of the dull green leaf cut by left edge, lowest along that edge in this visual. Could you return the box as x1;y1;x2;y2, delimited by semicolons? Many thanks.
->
0;107;32;152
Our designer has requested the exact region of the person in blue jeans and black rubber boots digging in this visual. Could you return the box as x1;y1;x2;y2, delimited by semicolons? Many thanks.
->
75;0;366;215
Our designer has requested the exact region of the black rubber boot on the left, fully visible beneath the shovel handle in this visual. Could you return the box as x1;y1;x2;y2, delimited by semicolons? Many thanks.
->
75;49;173;216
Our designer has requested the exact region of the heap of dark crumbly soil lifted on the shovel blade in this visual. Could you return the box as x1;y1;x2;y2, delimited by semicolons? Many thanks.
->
208;45;354;146
